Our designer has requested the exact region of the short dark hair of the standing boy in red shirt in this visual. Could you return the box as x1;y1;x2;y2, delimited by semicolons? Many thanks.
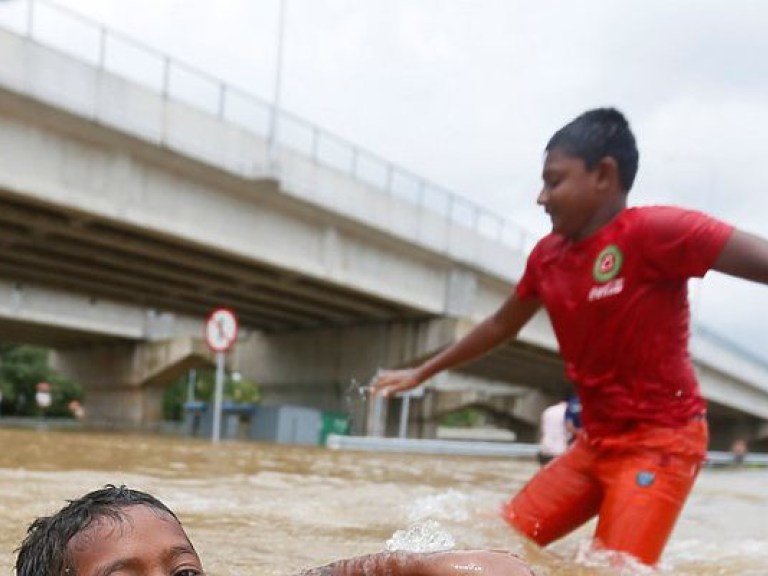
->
546;108;639;192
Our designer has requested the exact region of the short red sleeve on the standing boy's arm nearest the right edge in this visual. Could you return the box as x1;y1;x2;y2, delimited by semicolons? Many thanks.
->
639;206;733;279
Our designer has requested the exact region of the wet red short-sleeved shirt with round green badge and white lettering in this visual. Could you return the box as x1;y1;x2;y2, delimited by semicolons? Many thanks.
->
516;206;733;437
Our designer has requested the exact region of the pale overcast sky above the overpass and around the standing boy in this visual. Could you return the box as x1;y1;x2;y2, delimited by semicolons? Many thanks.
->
3;0;768;360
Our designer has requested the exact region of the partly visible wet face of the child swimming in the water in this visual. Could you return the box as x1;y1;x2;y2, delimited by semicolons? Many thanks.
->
69;505;203;576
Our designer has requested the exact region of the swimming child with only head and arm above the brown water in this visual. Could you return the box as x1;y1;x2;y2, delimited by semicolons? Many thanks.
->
16;485;533;576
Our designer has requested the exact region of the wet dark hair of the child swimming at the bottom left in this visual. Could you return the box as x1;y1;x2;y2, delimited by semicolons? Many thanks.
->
16;484;179;576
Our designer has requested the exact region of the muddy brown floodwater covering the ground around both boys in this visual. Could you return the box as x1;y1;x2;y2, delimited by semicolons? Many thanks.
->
0;428;768;576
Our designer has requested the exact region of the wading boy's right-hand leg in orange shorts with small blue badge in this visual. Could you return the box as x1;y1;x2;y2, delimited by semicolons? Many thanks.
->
595;421;707;565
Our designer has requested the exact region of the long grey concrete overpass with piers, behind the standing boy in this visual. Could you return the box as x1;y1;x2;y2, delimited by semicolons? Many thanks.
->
0;0;768;444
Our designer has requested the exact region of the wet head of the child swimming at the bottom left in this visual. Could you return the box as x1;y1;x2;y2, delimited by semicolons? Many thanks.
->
16;485;203;576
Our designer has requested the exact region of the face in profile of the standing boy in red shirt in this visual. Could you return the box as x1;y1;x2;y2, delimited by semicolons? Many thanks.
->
536;148;601;240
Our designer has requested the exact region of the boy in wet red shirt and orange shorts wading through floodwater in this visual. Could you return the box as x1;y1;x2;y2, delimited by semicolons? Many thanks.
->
374;108;768;564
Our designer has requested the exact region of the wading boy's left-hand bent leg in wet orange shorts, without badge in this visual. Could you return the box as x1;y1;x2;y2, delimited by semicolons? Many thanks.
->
502;438;602;546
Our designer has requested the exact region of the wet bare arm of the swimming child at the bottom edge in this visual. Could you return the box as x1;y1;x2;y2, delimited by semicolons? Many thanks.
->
300;550;535;576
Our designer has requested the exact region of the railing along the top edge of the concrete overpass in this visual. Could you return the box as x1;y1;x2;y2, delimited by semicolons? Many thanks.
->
0;0;535;252
